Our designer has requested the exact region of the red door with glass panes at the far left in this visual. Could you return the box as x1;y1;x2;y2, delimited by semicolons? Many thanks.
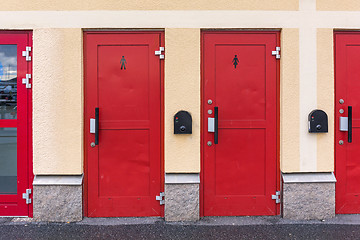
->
0;31;33;217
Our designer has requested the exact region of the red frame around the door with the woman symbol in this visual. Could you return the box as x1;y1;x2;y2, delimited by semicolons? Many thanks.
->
200;30;281;217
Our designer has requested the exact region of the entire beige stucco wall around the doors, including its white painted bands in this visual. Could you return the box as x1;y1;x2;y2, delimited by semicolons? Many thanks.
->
23;0;352;174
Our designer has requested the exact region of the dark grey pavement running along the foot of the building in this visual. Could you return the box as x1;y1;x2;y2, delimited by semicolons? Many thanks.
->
0;215;360;240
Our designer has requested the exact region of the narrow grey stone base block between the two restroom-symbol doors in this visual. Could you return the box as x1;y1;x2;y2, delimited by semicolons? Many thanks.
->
165;183;200;221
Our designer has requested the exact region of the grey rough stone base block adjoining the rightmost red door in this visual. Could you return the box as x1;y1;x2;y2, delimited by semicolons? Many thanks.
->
282;172;335;220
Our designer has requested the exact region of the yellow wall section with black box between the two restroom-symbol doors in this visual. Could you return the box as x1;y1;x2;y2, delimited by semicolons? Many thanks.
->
165;29;200;173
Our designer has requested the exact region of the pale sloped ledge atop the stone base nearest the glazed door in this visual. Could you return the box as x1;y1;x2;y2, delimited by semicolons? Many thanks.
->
33;175;83;186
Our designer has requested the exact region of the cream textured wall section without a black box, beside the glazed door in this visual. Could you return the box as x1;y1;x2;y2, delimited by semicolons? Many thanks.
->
33;29;83;174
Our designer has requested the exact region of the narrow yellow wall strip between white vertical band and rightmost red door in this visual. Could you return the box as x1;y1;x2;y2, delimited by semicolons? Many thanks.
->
317;28;335;172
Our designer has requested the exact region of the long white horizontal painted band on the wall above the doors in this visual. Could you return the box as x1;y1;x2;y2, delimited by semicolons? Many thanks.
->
0;10;360;29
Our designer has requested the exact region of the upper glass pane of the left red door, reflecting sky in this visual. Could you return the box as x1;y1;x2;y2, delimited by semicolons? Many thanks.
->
0;45;17;119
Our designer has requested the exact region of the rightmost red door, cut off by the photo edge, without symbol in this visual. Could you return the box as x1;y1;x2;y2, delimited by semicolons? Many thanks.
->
334;32;360;213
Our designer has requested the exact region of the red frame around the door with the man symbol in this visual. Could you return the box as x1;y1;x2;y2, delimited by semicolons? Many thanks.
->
83;30;165;217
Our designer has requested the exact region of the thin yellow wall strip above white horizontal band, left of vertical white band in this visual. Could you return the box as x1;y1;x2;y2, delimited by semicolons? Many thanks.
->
0;0;299;11
